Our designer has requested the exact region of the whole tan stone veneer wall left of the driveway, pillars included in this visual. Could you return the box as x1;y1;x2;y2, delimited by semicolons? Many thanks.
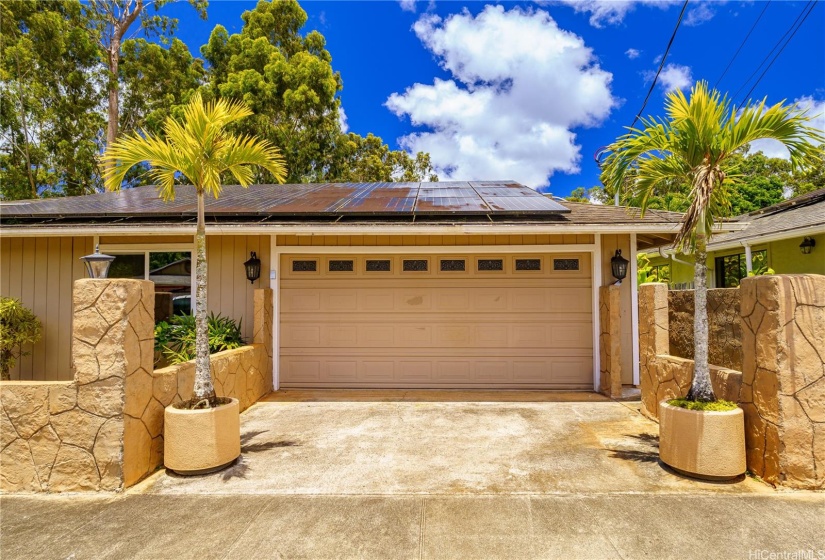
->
0;280;272;492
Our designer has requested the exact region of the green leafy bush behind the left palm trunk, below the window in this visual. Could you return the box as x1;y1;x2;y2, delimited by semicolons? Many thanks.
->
155;313;244;364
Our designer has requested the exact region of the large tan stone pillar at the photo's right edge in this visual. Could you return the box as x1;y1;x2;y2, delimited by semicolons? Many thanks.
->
740;274;825;489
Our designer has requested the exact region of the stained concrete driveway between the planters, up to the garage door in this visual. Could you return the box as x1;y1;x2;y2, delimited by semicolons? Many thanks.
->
136;390;770;495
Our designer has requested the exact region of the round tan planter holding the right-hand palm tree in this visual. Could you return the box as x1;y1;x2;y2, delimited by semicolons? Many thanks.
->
659;401;747;480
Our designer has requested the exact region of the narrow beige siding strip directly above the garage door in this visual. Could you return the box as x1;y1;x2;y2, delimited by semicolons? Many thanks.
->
278;234;593;247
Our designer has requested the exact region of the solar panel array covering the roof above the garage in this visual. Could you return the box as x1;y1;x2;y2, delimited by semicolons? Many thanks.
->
0;181;569;218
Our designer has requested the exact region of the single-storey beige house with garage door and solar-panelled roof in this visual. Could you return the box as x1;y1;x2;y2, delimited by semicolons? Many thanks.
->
0;181;696;389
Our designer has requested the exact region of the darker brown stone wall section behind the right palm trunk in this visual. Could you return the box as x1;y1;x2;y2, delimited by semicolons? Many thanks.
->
667;288;742;371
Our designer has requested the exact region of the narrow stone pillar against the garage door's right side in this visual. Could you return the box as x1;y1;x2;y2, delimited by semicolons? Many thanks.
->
599;284;622;398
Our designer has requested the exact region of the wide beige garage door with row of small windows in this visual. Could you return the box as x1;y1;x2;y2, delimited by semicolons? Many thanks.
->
280;253;593;389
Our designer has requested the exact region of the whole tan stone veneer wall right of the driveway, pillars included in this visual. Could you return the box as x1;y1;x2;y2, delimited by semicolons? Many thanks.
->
639;274;825;489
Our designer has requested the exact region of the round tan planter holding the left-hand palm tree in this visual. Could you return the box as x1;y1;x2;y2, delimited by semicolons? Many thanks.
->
163;399;241;475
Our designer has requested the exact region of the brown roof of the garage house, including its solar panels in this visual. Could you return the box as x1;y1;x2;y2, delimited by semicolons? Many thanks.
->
0;181;682;227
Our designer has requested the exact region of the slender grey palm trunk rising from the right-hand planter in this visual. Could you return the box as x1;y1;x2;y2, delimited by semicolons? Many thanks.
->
687;233;716;401
